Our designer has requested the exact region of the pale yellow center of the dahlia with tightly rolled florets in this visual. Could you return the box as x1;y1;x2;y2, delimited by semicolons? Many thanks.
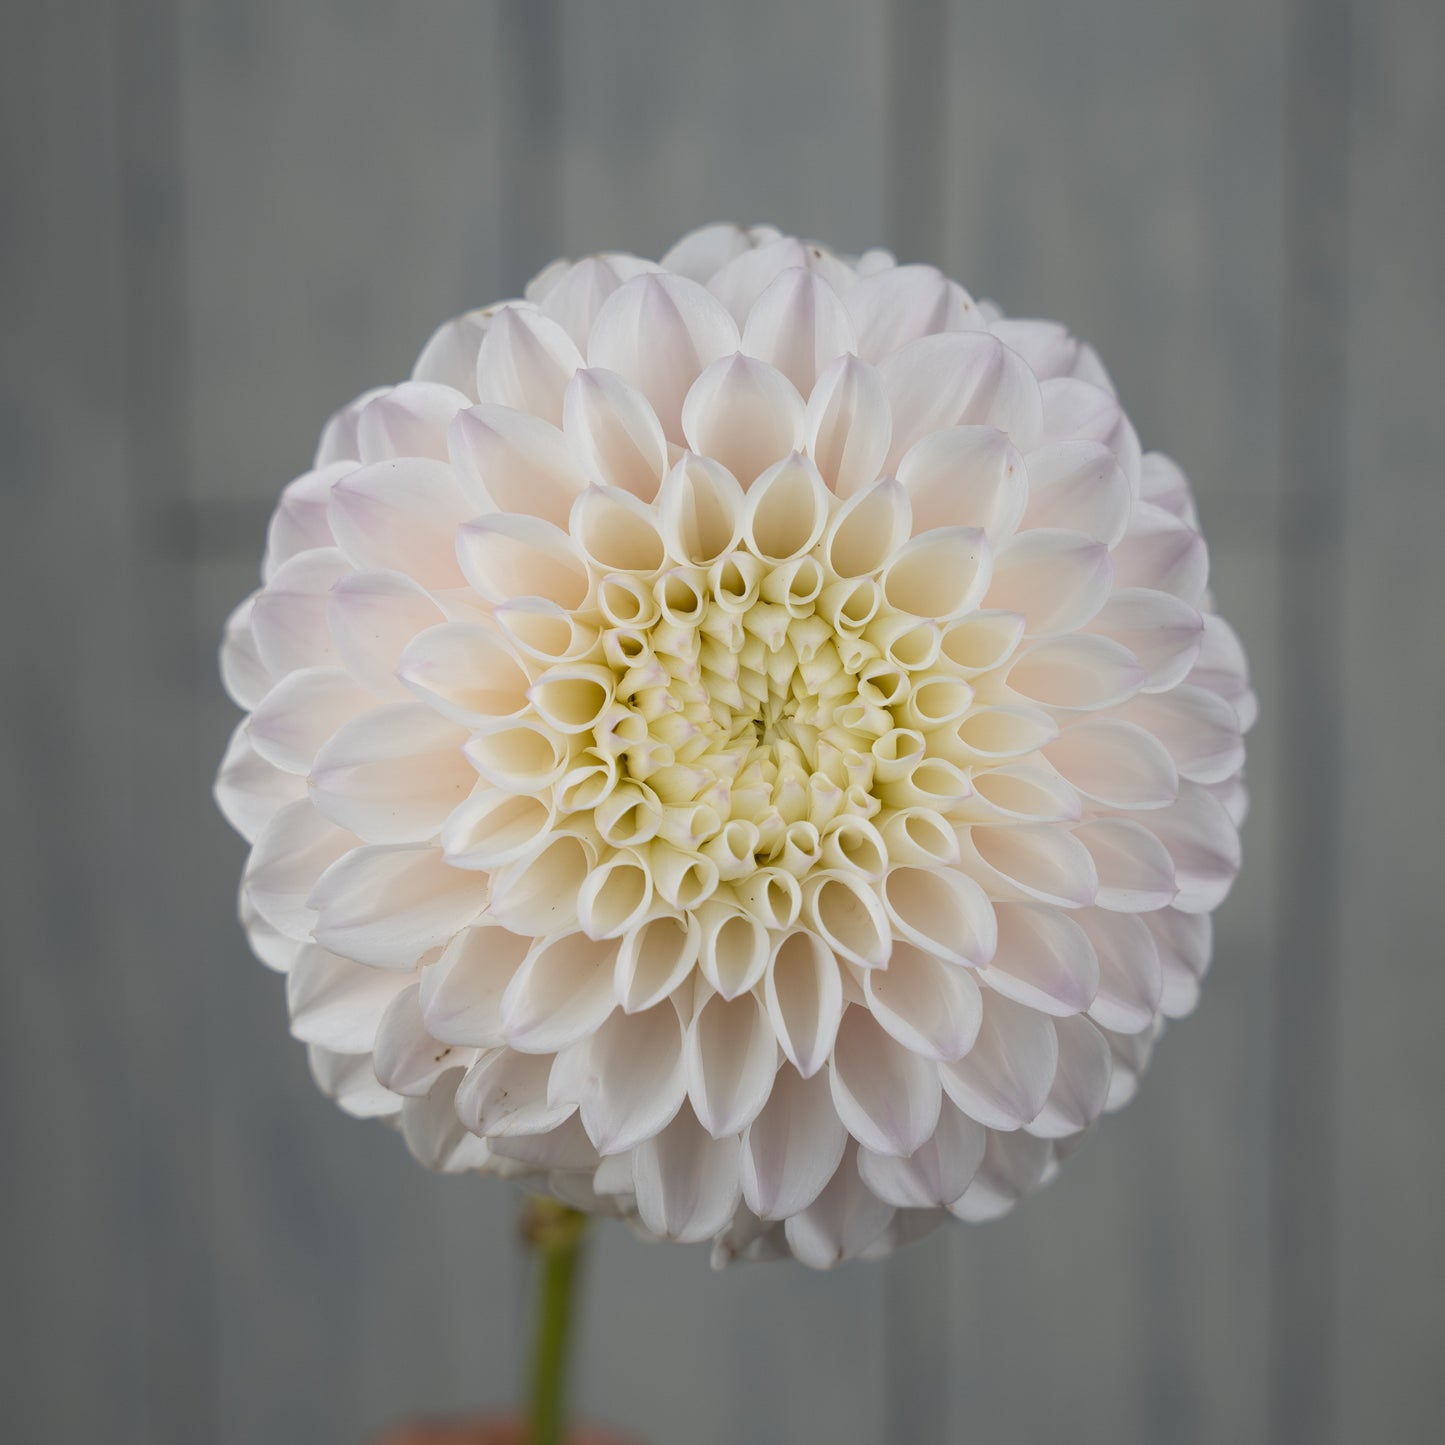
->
491;456;974;936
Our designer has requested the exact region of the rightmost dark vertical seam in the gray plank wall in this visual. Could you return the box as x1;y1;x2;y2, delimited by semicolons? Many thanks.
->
1266;0;1351;1445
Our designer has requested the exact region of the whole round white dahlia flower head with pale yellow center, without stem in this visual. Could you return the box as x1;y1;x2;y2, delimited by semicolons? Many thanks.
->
217;216;1254;1266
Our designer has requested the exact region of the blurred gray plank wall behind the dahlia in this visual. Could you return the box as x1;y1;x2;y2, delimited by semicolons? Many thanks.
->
0;0;1445;1445
